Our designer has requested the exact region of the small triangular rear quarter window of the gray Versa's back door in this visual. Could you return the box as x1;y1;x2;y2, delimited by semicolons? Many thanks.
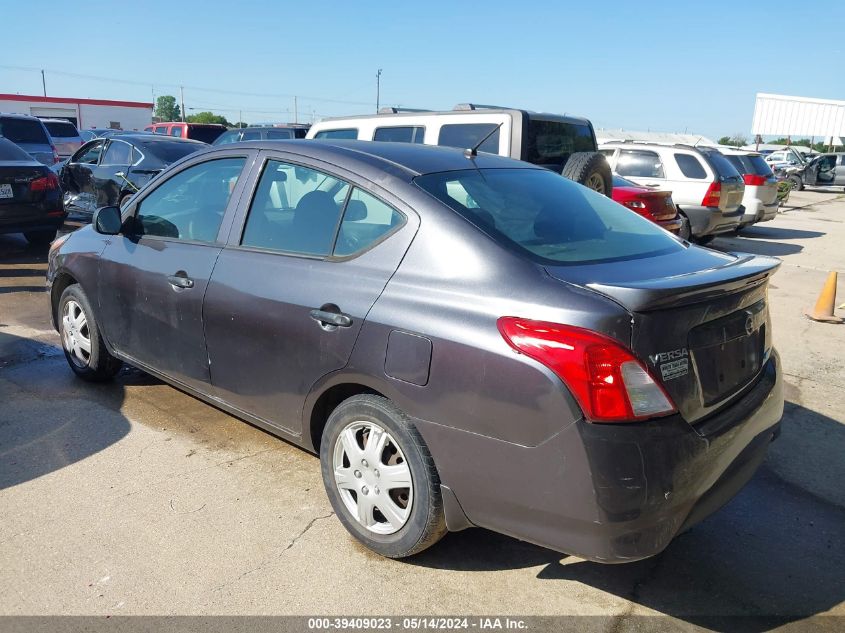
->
334;187;405;257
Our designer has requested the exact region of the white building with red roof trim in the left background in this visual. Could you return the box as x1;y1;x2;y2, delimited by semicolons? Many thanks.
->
0;94;153;130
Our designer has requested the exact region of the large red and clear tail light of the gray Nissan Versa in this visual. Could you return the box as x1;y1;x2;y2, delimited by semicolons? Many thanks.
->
498;317;677;422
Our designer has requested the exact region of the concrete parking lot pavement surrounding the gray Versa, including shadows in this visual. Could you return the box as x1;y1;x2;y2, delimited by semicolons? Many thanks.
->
0;190;845;630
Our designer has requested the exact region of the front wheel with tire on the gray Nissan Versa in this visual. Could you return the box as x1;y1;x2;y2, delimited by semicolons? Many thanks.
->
58;284;123;382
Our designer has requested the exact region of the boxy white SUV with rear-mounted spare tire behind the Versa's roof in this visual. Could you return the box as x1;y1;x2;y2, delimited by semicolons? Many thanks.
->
305;103;613;196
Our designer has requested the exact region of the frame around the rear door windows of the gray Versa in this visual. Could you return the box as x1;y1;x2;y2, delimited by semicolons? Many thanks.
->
224;149;408;263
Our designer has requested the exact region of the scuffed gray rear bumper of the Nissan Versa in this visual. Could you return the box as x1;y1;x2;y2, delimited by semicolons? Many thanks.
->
418;352;783;563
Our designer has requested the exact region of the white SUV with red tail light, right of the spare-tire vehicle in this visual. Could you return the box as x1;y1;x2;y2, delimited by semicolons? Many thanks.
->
599;141;745;244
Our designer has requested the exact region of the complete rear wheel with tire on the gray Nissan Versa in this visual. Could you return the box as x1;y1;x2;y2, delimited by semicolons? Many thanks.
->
320;394;447;558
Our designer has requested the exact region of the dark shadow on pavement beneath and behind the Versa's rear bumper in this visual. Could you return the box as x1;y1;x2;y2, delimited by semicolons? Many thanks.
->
409;403;845;633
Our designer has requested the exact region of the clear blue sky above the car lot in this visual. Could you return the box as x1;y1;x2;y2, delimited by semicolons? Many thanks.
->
0;0;845;137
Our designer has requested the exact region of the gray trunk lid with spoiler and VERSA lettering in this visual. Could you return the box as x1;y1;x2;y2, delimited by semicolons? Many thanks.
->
546;247;780;424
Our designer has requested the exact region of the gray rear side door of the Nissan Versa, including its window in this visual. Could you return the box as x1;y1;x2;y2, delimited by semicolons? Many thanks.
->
204;162;416;434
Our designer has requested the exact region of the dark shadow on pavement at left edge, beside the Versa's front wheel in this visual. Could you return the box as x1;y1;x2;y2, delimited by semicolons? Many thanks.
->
0;330;130;490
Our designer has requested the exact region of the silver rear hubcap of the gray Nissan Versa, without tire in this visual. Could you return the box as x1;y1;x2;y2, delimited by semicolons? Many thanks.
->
332;420;414;535
